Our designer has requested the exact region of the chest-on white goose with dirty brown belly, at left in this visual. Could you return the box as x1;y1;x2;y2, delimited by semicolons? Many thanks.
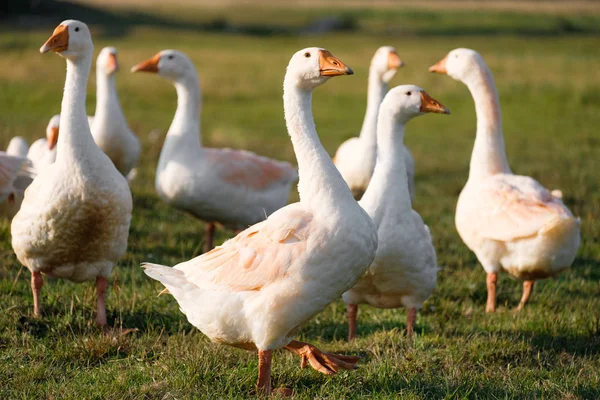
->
11;20;132;326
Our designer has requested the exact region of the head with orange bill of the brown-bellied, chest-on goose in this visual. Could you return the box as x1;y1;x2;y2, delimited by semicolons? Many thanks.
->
40;19;94;60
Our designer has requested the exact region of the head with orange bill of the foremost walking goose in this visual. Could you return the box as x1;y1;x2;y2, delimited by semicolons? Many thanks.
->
286;47;354;90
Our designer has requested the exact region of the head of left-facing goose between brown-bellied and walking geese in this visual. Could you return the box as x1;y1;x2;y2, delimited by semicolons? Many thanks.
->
131;50;196;81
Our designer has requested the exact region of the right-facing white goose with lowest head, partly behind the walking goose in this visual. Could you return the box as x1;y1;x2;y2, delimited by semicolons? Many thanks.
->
342;85;450;341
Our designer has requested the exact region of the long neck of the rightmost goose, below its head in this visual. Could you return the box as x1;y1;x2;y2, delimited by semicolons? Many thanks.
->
465;62;510;179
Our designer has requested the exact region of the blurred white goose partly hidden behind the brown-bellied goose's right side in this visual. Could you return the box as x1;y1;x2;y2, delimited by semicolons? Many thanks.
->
88;47;141;176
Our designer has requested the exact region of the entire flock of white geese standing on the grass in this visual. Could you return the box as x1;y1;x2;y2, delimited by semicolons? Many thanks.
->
0;20;580;394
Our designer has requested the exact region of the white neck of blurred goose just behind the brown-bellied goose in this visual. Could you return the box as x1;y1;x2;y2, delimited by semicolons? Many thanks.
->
94;68;127;127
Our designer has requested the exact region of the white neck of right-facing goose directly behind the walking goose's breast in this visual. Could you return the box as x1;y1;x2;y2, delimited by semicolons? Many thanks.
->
360;109;412;226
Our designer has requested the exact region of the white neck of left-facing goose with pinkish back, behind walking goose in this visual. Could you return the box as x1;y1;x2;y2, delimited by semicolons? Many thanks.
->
159;73;202;168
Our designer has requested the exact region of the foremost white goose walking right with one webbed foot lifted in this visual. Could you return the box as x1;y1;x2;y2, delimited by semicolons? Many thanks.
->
144;48;377;394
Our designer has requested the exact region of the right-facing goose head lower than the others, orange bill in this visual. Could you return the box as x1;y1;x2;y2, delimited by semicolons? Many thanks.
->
380;85;450;123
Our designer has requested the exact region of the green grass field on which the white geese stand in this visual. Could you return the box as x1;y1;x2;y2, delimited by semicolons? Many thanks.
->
0;0;600;399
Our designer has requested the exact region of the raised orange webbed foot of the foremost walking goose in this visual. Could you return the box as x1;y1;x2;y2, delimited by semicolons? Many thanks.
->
284;340;360;375
